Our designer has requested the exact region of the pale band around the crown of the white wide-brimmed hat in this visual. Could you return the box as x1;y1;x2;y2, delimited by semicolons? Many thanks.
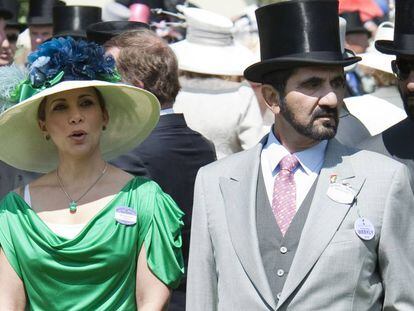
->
186;27;233;46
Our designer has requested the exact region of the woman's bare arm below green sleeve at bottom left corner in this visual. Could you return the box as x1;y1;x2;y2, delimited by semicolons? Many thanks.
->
0;247;26;311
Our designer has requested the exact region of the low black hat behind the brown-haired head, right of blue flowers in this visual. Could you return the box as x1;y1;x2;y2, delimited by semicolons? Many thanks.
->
86;21;149;45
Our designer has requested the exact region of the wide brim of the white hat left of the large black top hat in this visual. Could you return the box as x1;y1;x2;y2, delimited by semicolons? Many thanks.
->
170;40;256;76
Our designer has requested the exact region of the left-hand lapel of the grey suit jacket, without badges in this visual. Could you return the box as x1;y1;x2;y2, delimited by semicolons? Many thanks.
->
220;140;276;310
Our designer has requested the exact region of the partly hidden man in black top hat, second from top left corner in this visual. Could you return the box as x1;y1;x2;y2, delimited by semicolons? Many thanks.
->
27;0;64;51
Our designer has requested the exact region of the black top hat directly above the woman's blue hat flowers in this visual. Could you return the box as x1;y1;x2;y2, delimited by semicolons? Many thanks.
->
53;6;102;39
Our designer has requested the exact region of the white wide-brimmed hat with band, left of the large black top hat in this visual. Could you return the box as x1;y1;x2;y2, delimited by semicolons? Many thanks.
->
171;7;255;76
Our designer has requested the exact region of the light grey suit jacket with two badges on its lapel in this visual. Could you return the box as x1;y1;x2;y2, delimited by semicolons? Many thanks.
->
187;140;414;311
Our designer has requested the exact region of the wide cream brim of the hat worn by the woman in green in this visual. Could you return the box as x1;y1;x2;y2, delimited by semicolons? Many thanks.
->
0;80;160;173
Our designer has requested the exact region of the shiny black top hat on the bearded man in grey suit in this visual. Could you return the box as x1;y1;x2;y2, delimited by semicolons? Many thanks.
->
244;0;361;82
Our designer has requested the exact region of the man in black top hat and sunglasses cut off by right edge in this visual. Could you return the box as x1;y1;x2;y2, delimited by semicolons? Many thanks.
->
360;0;414;191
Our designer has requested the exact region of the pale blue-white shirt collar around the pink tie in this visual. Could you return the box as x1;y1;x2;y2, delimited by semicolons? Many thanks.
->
262;130;328;175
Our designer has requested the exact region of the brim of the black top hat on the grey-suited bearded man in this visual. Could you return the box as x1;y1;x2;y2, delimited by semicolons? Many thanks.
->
244;56;361;83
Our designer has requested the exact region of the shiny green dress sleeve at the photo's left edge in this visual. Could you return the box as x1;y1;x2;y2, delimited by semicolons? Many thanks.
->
0;193;22;278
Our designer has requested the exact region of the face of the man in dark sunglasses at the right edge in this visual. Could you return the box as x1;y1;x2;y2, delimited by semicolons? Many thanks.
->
393;56;414;120
